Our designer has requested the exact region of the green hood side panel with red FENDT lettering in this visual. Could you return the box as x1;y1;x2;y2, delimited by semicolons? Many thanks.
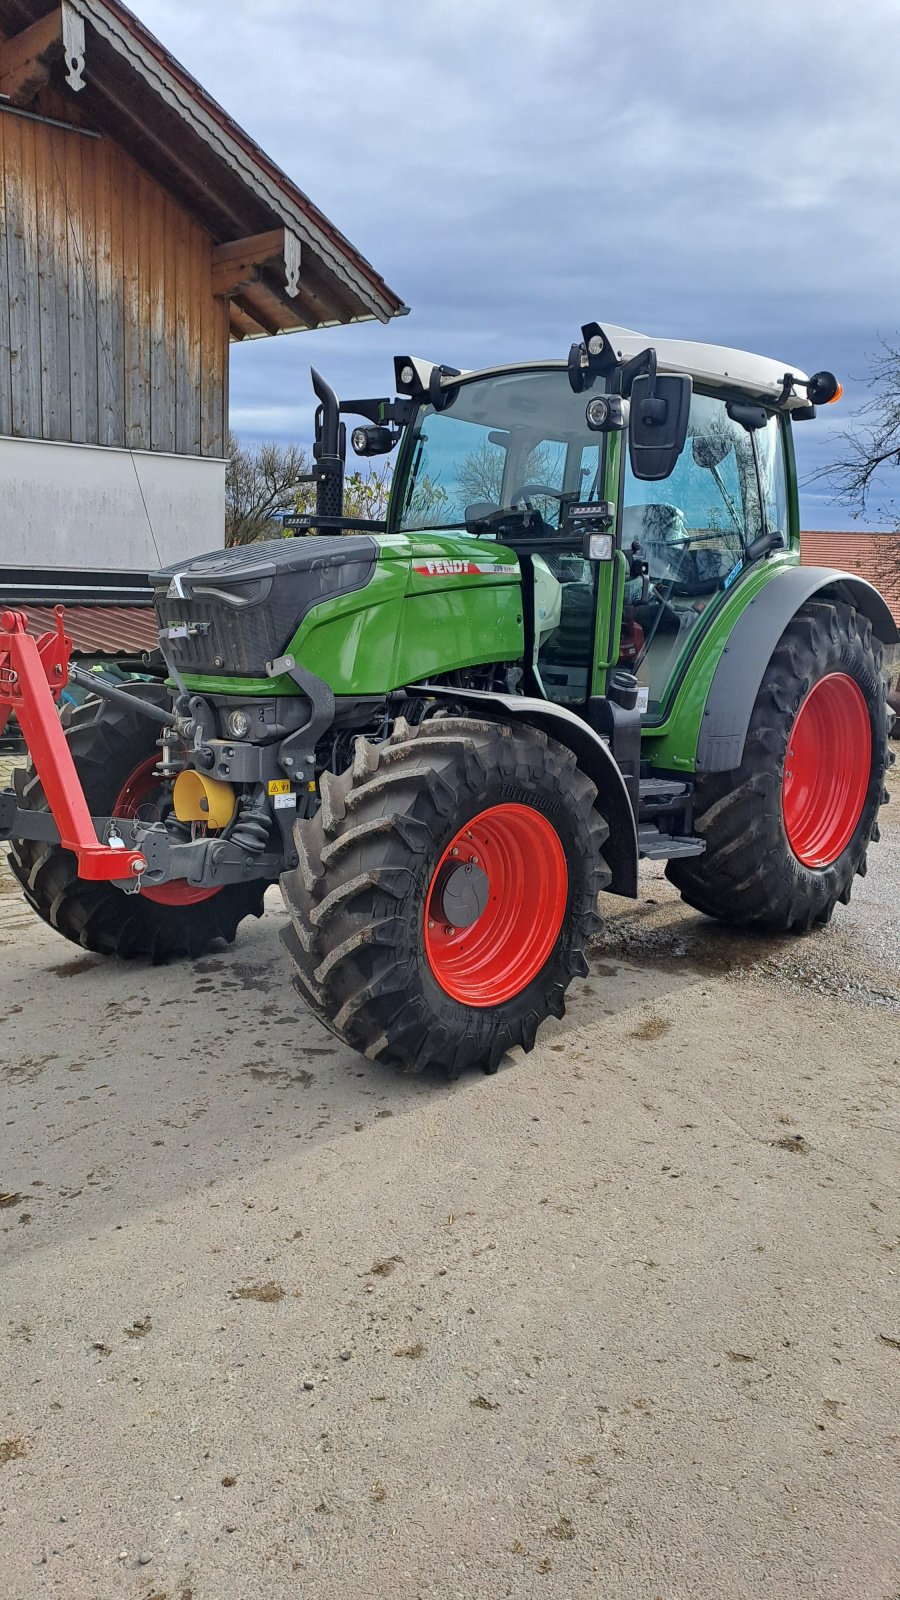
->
184;531;524;698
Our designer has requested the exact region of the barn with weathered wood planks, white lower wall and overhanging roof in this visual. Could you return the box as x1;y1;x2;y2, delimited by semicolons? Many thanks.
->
0;0;405;652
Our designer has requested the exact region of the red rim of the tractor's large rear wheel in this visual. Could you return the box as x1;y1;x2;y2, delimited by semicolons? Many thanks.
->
781;672;871;867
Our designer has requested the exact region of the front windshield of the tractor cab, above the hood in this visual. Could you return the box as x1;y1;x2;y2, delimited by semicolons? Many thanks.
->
394;370;602;531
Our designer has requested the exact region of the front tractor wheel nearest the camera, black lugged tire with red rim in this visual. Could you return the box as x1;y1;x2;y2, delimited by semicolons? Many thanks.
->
282;717;610;1078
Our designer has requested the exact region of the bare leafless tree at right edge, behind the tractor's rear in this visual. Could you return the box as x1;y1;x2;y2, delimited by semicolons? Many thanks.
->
812;339;900;525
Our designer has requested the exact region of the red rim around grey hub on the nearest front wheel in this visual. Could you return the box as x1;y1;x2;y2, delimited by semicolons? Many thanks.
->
424;805;569;1006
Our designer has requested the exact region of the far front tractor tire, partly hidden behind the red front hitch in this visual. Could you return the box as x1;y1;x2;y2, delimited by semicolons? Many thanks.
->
10;683;266;963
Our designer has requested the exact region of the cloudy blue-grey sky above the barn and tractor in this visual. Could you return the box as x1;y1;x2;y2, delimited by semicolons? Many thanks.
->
131;0;900;528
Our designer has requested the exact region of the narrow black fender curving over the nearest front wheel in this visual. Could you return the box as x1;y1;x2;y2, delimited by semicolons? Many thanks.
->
407;683;637;899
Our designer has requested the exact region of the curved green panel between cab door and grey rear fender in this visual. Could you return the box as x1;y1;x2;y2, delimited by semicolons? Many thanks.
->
642;550;799;773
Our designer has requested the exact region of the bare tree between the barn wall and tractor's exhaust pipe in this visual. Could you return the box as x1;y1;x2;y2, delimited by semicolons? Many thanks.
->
226;434;315;544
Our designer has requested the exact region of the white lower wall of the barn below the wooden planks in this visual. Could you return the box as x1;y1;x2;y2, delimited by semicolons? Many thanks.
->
0;437;226;571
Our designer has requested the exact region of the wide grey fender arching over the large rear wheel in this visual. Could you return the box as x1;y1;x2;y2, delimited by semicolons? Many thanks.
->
697;566;900;773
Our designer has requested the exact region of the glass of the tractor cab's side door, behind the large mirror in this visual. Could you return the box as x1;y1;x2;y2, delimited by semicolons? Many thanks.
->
621;394;762;714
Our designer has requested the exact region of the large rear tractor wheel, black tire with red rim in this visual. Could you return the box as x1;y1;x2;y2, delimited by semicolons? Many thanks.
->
666;602;894;933
